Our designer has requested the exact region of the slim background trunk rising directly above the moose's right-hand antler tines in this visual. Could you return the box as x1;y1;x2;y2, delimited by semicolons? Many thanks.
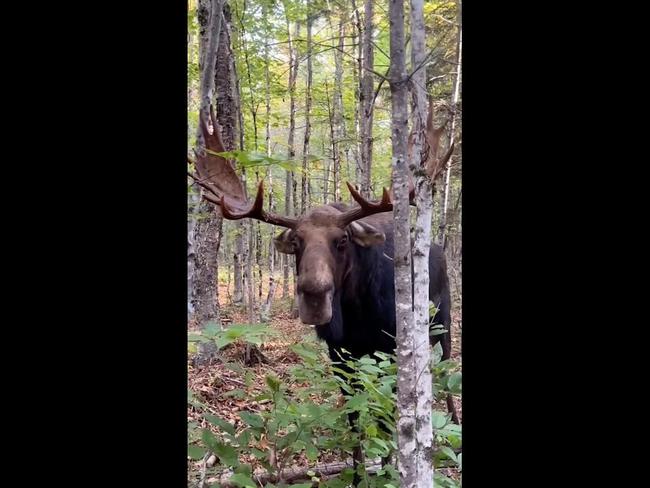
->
361;0;374;198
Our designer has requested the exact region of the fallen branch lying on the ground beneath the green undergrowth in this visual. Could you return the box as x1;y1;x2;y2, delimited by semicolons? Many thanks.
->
208;460;381;488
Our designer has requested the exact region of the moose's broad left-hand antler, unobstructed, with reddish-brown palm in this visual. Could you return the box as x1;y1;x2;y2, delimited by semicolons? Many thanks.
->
190;107;297;229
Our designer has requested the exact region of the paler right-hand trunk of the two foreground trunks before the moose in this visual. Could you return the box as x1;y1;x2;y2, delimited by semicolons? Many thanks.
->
400;0;433;487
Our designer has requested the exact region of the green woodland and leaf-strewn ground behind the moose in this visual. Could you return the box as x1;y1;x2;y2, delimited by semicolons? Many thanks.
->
187;0;462;486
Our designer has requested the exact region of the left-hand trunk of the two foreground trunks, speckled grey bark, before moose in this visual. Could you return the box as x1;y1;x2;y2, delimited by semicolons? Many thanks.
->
389;0;433;488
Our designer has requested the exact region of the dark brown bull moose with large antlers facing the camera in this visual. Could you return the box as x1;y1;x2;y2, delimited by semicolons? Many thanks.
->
194;106;458;465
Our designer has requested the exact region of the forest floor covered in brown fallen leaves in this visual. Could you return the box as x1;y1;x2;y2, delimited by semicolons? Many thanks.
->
187;276;462;486
